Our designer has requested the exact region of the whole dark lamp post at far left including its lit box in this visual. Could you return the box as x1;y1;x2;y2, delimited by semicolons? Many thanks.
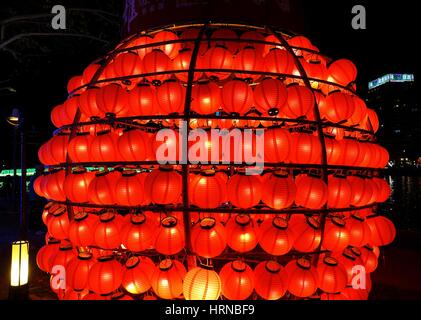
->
7;109;29;299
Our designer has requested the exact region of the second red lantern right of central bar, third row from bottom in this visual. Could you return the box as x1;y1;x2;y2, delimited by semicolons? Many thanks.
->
227;174;262;209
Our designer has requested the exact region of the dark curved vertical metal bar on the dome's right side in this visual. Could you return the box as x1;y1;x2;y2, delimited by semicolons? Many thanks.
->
268;27;328;265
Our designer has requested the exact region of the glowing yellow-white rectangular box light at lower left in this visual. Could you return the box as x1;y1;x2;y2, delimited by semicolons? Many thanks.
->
10;241;29;287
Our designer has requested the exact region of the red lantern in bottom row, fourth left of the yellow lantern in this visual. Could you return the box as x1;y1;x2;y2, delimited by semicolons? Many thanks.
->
66;252;95;291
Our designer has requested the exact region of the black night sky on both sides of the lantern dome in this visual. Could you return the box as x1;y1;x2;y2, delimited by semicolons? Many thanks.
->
0;0;421;166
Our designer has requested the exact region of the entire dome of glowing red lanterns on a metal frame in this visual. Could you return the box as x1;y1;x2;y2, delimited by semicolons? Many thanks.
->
34;23;396;300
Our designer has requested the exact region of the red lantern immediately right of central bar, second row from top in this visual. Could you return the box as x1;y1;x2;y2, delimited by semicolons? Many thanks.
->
201;46;234;81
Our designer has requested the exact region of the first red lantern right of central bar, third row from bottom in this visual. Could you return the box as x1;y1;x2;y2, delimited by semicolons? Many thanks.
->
189;170;227;208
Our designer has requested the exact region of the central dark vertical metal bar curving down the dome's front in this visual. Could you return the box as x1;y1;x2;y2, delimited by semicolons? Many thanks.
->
181;23;209;255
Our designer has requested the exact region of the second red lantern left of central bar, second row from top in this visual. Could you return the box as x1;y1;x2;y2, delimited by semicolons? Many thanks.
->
143;49;172;84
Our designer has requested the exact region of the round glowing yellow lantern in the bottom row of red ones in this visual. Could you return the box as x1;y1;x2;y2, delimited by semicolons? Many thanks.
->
183;267;221;300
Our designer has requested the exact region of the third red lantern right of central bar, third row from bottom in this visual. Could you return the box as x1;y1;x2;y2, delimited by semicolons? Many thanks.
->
262;172;296;209
